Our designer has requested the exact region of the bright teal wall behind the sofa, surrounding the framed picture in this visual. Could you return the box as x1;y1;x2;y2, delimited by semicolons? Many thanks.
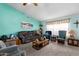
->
0;4;40;35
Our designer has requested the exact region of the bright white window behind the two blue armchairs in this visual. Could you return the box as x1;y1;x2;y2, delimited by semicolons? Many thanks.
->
46;23;68;35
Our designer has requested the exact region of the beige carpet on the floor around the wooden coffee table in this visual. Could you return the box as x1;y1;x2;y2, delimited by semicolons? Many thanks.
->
19;42;79;56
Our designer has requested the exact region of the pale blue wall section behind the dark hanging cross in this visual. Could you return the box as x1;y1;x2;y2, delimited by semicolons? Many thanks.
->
69;16;79;39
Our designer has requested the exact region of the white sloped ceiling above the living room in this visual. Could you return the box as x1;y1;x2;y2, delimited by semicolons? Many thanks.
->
9;3;79;21
